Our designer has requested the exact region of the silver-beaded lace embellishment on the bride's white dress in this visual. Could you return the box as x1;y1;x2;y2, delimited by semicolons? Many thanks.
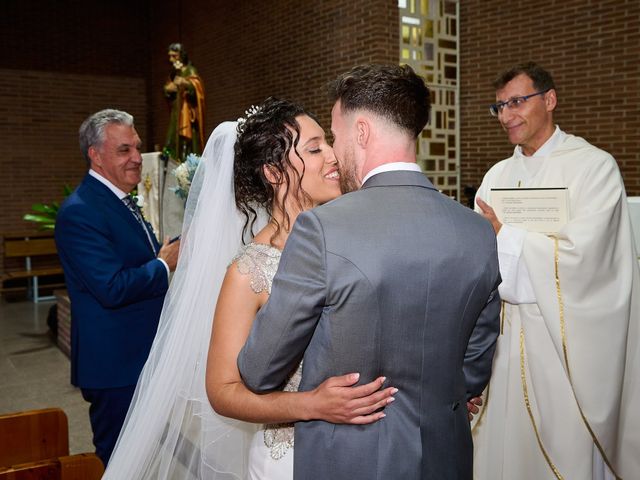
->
233;243;302;460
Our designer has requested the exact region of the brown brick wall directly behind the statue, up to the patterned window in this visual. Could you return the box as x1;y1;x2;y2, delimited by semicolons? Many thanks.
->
150;0;399;148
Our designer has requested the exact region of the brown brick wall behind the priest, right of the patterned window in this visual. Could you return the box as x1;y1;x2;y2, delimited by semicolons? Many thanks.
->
460;0;640;202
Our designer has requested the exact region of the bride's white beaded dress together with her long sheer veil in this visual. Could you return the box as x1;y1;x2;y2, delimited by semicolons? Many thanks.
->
103;122;299;480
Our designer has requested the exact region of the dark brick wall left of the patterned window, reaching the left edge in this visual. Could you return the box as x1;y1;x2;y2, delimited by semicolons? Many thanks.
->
0;0;398;269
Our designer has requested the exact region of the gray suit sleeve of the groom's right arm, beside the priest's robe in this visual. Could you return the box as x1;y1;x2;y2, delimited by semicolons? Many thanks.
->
463;254;501;399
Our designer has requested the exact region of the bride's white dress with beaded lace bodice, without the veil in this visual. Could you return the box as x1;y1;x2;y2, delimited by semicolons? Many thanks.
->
231;243;302;480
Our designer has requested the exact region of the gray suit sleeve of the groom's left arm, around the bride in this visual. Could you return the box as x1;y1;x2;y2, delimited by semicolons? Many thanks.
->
238;212;326;392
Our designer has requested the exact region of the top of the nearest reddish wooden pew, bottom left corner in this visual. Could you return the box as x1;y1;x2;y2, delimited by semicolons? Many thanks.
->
0;453;104;480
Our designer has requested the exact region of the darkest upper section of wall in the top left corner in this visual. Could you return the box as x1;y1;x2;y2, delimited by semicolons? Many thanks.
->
0;0;150;77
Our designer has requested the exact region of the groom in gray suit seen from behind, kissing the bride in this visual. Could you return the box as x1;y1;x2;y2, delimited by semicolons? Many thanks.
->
238;65;500;480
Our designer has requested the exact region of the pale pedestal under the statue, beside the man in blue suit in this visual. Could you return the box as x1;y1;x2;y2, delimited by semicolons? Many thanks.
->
138;152;184;243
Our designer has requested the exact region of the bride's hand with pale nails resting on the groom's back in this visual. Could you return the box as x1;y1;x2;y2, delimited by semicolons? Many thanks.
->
303;373;398;425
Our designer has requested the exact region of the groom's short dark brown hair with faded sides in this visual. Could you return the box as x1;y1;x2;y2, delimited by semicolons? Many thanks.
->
328;64;431;138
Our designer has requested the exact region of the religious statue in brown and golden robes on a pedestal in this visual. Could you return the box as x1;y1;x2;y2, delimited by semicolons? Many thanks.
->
162;43;204;163
